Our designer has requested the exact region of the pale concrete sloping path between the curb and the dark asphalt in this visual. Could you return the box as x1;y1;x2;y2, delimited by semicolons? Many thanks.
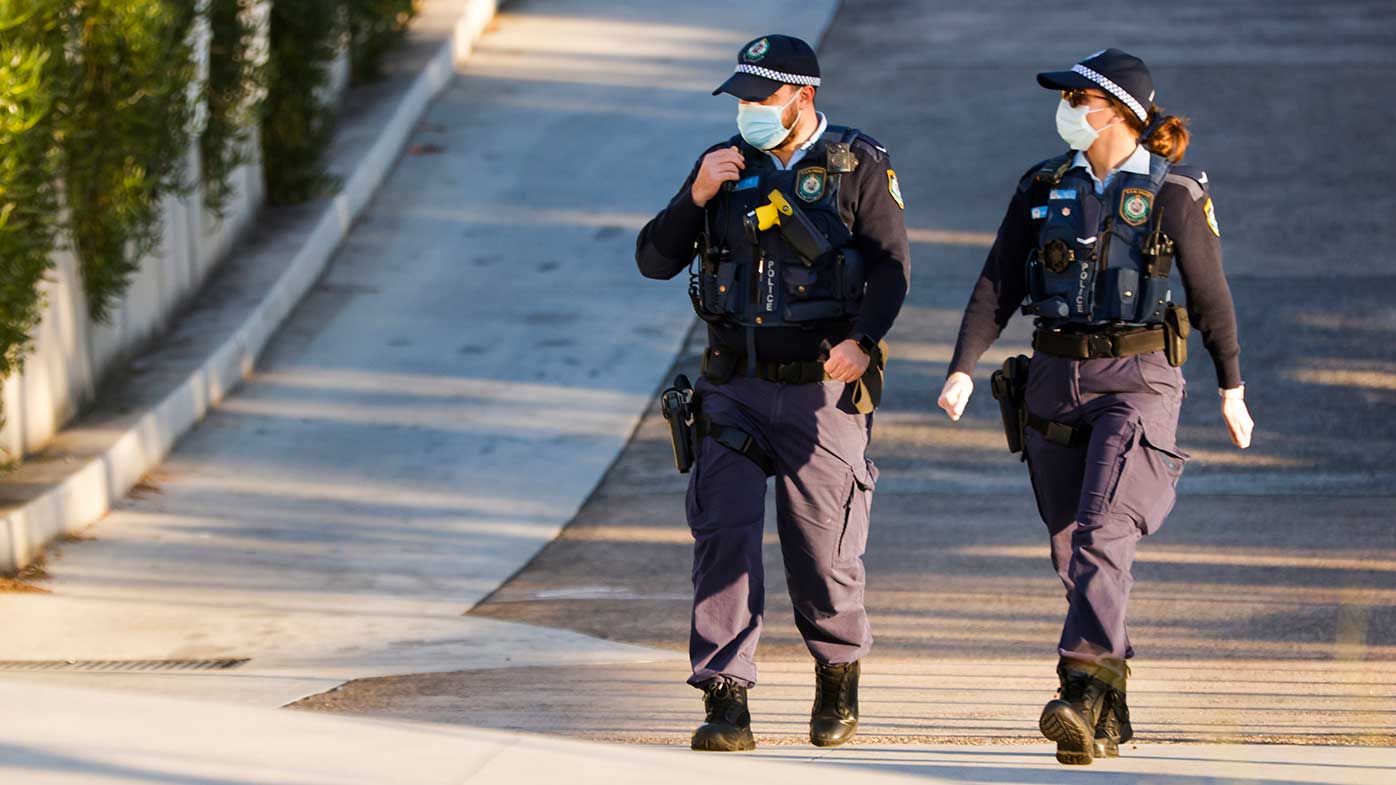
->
0;0;833;743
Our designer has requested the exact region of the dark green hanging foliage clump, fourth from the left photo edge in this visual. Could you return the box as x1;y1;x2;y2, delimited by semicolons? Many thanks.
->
261;0;345;204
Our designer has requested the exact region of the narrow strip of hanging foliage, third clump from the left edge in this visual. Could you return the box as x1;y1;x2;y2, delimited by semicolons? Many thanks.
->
200;0;262;218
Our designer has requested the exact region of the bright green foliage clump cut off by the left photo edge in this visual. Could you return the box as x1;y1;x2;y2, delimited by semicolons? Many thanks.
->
0;0;66;379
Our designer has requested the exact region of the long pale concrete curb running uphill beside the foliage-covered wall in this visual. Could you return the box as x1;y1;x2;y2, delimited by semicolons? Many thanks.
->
0;0;500;573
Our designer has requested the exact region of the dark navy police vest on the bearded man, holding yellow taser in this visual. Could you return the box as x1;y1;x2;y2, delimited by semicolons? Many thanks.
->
690;126;864;329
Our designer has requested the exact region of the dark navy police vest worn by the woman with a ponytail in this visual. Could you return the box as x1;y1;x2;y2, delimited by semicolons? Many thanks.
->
1023;154;1173;327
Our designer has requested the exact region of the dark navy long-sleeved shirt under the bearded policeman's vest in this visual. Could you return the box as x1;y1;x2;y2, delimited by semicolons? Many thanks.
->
635;116;912;362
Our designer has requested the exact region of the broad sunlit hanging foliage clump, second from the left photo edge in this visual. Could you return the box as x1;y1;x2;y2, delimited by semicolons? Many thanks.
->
59;0;197;321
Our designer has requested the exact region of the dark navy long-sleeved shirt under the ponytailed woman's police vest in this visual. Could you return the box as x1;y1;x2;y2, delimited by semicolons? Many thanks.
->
949;148;1241;390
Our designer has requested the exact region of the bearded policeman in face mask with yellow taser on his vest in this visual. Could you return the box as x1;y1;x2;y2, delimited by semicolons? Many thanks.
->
635;35;910;750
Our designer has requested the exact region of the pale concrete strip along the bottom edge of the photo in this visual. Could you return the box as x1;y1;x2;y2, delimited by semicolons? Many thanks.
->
0;680;1396;785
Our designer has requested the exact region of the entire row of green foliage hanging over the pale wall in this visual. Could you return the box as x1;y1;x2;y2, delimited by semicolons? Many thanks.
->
0;0;415;455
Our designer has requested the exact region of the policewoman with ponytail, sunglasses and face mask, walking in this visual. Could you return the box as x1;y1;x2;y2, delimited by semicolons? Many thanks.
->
940;49;1252;764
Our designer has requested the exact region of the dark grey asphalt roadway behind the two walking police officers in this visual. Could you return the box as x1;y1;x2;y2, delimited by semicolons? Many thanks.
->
304;0;1396;757
